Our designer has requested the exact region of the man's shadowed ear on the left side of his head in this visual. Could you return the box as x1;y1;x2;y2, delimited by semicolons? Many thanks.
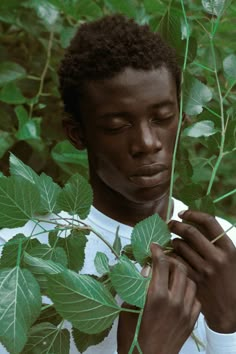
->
62;118;86;150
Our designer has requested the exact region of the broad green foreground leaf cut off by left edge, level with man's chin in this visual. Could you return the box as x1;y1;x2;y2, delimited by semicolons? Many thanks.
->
0;176;40;228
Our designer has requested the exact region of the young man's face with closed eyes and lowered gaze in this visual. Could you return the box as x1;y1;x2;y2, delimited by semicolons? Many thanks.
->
81;67;179;203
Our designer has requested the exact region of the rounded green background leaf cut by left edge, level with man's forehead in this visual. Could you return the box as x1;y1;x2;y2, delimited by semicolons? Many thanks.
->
0;62;26;86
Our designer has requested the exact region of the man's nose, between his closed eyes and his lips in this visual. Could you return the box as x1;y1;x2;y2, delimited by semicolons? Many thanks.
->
131;122;162;157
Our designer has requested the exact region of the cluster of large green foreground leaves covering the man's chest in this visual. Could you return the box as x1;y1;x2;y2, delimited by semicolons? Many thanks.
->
0;154;170;354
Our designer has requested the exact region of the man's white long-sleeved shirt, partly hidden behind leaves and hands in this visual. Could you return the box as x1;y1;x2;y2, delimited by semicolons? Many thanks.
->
0;200;236;354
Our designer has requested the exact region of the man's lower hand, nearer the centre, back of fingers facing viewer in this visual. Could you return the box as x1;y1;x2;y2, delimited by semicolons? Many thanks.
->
118;244;201;354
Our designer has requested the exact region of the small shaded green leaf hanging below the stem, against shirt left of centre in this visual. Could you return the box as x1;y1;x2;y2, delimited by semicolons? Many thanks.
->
49;230;88;272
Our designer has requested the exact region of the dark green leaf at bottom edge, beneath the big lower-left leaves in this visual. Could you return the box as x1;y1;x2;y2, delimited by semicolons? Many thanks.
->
22;322;70;354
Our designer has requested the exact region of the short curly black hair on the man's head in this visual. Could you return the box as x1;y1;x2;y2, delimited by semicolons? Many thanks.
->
59;14;181;121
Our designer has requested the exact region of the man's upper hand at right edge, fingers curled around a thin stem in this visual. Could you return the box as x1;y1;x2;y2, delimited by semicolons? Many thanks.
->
169;210;236;333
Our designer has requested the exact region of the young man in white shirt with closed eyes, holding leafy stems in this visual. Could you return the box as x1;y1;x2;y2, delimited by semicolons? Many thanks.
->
59;15;236;354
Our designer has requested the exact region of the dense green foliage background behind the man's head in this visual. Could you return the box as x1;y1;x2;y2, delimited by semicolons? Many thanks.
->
0;0;236;221
